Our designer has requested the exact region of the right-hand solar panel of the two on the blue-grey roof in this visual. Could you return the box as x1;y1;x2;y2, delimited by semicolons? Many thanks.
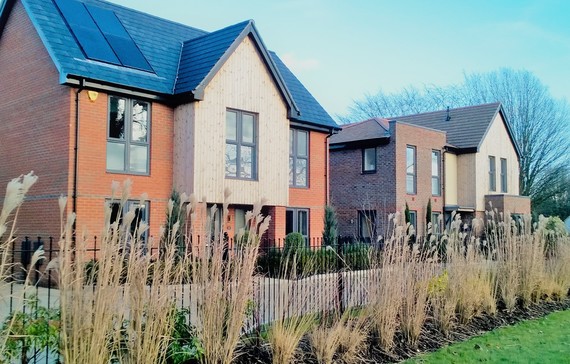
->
85;4;153;72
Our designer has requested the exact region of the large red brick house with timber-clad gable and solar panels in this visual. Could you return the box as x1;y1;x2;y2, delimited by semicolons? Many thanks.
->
0;0;338;246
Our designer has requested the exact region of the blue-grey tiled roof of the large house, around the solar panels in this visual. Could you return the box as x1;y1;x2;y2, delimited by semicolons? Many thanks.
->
4;0;338;128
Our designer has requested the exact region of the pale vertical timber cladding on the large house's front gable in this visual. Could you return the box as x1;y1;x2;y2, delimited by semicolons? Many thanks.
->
174;38;289;206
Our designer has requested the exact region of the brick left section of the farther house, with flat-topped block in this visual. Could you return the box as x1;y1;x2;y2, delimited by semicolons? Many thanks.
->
330;118;446;240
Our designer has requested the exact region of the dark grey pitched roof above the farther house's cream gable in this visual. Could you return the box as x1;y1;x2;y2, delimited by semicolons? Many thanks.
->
389;102;504;150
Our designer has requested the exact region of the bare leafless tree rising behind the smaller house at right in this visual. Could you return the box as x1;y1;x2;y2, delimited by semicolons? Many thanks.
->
339;68;570;213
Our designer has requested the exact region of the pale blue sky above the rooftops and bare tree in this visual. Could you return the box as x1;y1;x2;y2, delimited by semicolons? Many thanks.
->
107;0;570;119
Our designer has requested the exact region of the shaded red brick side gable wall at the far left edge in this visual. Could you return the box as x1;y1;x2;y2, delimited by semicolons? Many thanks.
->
0;2;73;237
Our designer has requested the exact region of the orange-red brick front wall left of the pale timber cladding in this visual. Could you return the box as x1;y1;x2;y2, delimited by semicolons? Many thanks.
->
77;91;174;246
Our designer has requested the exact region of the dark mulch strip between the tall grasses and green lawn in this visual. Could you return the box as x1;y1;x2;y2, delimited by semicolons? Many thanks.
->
235;298;570;364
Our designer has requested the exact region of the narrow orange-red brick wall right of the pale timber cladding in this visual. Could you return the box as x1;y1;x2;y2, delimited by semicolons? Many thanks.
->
288;131;328;242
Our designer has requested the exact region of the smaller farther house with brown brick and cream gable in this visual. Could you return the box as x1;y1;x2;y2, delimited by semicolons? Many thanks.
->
330;103;530;236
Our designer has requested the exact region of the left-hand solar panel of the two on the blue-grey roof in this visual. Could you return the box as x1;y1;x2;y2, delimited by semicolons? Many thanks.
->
55;0;121;65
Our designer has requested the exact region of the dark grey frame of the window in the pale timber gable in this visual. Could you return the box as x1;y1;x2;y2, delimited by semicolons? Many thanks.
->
224;108;259;181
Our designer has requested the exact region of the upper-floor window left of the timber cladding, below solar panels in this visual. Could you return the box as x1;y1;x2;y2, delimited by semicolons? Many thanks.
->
107;96;150;174
